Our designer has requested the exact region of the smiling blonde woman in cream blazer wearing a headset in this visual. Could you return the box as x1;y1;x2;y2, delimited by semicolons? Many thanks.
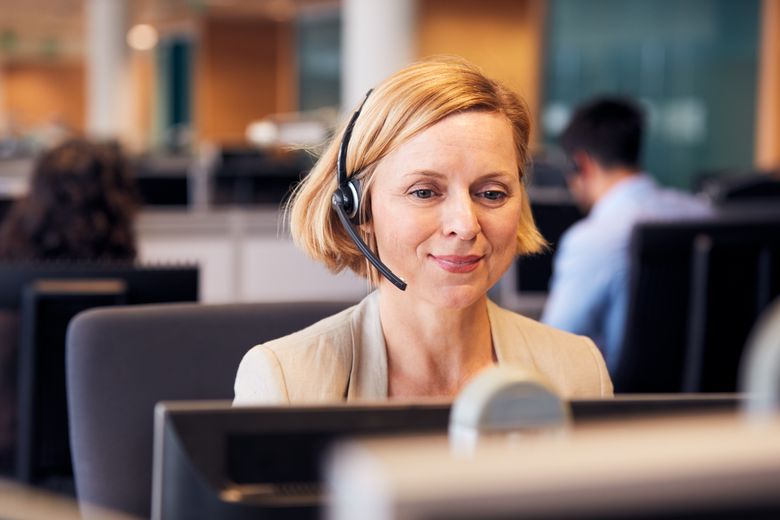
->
235;59;612;404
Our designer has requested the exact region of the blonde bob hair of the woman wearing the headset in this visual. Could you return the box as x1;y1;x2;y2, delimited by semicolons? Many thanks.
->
287;57;545;285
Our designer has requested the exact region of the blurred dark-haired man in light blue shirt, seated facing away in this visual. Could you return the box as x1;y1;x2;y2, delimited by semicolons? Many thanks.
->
541;98;711;370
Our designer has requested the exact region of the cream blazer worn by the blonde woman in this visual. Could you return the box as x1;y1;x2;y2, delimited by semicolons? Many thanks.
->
233;292;612;405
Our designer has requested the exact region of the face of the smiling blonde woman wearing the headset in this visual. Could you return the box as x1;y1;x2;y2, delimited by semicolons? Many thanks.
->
365;111;522;308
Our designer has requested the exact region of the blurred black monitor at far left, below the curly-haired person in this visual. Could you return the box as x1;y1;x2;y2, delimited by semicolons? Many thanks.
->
0;262;198;492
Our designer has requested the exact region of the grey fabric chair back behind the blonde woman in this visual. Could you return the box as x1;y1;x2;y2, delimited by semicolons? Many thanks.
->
67;302;349;518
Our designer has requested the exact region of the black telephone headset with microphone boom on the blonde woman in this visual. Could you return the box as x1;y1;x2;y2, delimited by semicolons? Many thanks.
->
331;90;406;291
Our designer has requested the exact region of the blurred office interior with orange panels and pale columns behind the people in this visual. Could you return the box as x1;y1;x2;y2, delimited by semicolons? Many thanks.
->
0;0;780;308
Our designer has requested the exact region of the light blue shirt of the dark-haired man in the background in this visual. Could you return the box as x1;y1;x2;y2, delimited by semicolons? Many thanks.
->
541;174;711;371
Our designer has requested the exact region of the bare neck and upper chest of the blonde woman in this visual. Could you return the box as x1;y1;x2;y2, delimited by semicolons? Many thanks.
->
379;288;493;397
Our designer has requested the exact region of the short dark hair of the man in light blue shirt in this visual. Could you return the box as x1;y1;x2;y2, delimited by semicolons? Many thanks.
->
560;97;645;169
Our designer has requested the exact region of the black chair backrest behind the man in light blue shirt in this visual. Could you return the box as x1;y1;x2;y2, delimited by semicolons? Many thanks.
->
612;215;780;392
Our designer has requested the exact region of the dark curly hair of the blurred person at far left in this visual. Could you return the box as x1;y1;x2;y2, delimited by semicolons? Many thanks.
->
0;139;139;260
